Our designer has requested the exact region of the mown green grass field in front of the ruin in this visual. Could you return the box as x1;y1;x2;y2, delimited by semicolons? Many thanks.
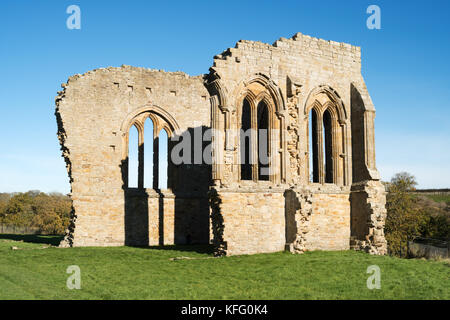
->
0;235;450;299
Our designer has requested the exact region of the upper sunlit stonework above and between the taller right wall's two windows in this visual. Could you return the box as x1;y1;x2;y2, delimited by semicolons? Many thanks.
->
212;33;373;185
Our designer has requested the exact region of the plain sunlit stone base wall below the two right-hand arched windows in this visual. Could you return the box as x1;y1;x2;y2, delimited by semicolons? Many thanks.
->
213;187;350;255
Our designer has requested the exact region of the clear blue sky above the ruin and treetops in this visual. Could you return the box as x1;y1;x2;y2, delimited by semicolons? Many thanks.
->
0;0;450;192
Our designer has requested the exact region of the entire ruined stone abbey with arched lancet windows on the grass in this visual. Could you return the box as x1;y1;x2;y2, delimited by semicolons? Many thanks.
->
55;33;386;255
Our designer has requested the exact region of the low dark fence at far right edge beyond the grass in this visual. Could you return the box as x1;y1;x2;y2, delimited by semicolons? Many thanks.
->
408;238;450;259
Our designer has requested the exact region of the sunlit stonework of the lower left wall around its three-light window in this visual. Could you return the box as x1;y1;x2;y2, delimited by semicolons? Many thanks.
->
56;66;210;246
